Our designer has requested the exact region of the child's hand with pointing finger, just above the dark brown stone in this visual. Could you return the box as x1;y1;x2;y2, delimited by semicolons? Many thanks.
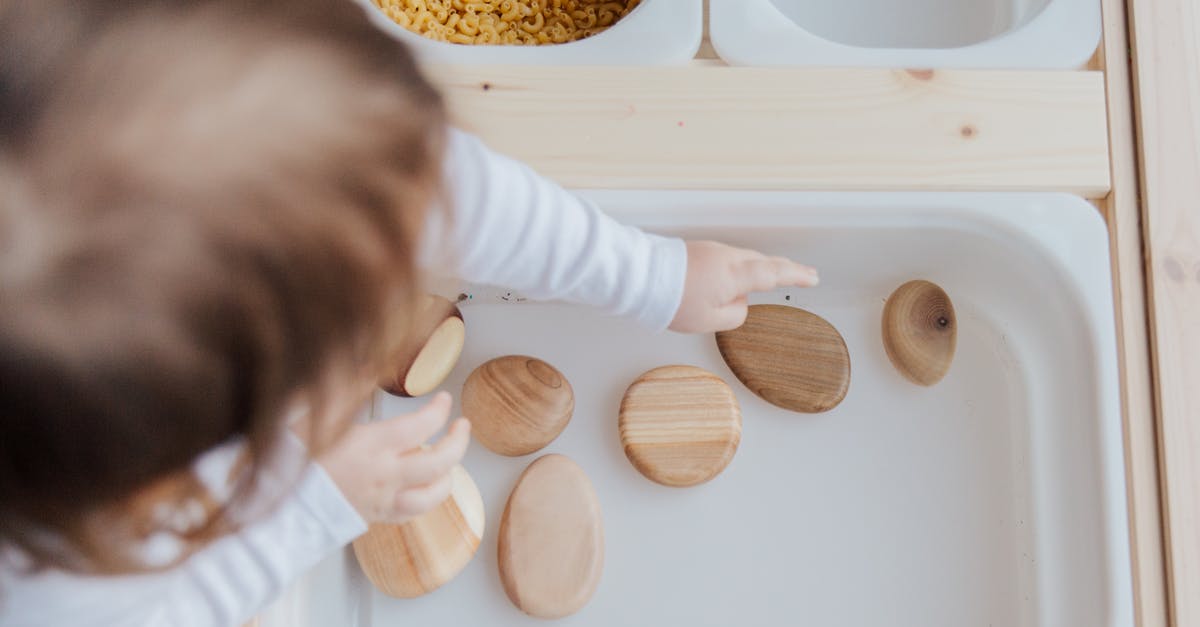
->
671;241;817;333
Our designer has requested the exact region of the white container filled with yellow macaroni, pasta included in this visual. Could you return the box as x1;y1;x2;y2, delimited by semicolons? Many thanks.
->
355;0;704;65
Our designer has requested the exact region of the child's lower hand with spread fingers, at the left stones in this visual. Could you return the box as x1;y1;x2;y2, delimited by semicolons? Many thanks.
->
318;392;470;524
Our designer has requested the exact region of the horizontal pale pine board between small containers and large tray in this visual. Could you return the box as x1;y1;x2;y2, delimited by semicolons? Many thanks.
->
428;66;1109;197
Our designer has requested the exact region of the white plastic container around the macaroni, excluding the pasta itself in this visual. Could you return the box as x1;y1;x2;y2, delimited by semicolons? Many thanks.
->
355;0;704;65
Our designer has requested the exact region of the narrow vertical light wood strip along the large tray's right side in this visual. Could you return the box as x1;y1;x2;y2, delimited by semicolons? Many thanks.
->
1094;0;1168;627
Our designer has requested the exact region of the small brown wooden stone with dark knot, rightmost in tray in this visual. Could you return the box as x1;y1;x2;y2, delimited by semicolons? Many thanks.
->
883;280;958;386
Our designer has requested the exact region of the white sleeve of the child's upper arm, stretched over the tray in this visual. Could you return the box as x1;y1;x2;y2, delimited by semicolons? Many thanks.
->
421;130;688;330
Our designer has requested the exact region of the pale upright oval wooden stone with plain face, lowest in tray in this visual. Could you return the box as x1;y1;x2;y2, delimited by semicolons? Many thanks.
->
499;455;604;619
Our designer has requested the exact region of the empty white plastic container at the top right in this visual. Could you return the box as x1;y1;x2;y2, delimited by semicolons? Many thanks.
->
709;0;1100;70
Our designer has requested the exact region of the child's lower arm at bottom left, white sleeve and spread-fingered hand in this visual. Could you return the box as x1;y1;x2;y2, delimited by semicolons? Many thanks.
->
0;393;468;627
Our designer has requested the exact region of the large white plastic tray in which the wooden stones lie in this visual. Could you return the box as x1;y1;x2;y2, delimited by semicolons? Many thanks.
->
264;191;1134;627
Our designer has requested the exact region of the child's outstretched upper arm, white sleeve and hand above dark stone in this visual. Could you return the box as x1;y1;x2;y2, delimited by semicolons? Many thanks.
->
422;131;817;332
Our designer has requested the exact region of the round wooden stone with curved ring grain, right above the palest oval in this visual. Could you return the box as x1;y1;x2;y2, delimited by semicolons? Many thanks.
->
462;356;575;456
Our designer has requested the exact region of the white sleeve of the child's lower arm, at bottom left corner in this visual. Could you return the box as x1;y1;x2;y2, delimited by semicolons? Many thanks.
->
0;438;367;627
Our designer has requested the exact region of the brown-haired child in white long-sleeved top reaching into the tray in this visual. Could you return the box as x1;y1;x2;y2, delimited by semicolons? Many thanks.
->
0;0;816;627
